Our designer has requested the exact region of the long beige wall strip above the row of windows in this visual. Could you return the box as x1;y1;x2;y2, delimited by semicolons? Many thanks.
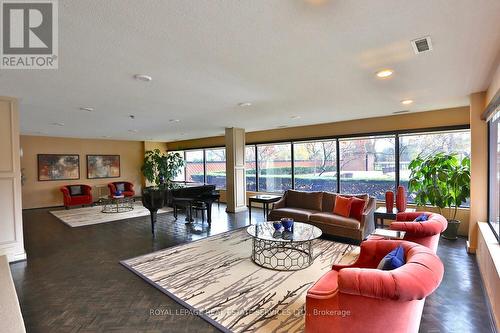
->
167;106;470;150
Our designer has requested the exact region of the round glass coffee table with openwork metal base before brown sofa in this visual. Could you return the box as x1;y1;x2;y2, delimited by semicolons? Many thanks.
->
247;222;322;271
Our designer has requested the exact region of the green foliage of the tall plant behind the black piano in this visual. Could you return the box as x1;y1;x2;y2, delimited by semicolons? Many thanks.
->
141;149;184;187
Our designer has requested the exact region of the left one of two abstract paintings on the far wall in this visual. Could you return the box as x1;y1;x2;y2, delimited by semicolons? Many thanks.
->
38;154;80;181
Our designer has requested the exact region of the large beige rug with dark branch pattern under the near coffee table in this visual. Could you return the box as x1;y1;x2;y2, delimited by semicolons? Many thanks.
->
121;228;359;333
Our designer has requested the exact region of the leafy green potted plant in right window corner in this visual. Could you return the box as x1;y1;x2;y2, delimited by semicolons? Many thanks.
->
408;153;470;239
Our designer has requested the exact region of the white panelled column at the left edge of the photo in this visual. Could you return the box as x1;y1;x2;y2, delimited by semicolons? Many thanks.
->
0;97;26;261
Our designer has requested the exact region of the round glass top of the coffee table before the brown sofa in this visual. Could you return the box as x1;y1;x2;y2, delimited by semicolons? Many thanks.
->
247;222;322;242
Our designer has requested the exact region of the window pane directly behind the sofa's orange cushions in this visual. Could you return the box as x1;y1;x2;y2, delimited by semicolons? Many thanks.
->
339;136;396;200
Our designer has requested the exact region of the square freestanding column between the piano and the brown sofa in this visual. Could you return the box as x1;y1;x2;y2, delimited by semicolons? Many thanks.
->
226;128;247;213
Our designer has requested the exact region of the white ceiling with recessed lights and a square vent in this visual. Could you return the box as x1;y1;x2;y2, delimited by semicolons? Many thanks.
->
0;0;500;141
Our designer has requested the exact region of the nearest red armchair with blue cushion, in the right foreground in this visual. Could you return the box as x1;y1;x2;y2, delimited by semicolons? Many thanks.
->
306;240;444;333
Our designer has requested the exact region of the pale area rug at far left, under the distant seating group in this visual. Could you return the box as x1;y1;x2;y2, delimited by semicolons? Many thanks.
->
50;201;172;228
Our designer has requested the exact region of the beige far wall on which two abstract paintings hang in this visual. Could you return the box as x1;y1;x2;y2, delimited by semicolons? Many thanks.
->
21;135;144;209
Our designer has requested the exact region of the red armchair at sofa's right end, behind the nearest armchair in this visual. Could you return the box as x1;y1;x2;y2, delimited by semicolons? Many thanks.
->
389;212;448;253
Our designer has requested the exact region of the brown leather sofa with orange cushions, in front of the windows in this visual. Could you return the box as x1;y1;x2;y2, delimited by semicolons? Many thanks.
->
267;190;376;241
